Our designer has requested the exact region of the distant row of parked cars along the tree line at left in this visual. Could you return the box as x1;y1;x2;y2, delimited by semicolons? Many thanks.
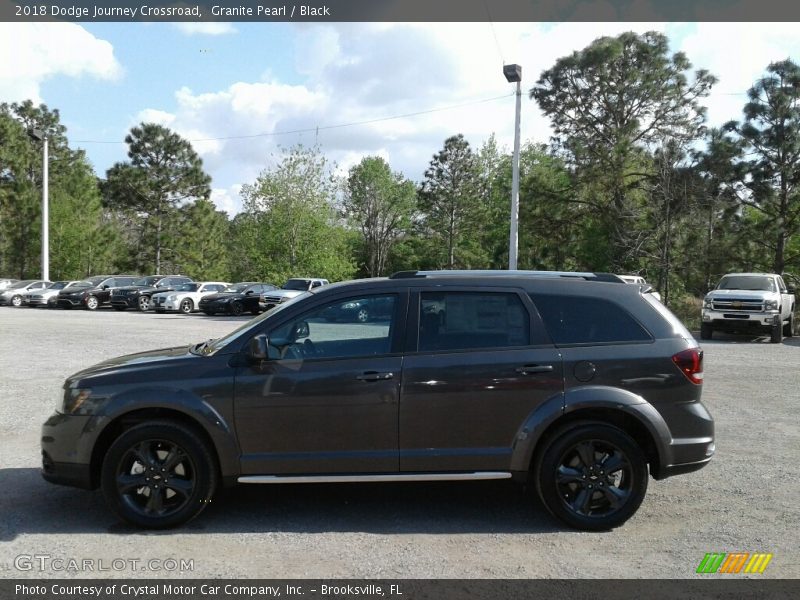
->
0;275;329;316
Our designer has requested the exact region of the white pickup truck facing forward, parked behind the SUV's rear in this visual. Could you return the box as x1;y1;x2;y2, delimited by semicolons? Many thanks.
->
700;273;795;344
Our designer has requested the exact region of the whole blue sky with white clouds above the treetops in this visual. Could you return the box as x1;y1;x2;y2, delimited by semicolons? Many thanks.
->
0;23;800;214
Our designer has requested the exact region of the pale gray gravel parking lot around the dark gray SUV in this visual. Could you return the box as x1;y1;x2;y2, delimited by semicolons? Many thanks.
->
0;308;800;579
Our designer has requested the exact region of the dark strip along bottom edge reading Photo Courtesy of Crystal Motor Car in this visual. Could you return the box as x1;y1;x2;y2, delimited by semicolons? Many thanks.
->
0;577;800;600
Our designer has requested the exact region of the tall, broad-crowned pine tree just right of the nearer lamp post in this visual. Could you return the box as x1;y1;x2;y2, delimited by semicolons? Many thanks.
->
530;32;716;270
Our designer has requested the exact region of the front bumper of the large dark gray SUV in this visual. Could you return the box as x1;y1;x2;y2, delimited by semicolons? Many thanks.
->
41;413;97;489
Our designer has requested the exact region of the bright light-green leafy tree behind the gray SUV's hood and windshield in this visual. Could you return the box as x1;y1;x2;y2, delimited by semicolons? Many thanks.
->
235;146;355;284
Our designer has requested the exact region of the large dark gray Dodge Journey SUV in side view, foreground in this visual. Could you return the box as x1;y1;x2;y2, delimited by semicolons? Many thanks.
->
42;272;714;530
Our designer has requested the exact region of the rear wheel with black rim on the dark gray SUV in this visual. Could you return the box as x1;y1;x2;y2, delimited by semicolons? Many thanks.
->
535;422;648;531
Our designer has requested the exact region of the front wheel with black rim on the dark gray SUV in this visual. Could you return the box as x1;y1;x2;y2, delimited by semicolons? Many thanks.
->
100;421;217;529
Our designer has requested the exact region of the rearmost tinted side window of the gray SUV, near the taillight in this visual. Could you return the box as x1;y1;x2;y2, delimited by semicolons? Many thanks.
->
531;294;652;345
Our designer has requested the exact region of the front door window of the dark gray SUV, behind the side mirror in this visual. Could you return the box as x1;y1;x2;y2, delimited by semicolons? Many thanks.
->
269;294;397;358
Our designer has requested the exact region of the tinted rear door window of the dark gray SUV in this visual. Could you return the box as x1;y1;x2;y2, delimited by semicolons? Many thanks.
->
417;292;530;351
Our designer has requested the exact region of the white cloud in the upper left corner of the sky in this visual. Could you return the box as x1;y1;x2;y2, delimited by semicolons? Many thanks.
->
0;23;122;103
